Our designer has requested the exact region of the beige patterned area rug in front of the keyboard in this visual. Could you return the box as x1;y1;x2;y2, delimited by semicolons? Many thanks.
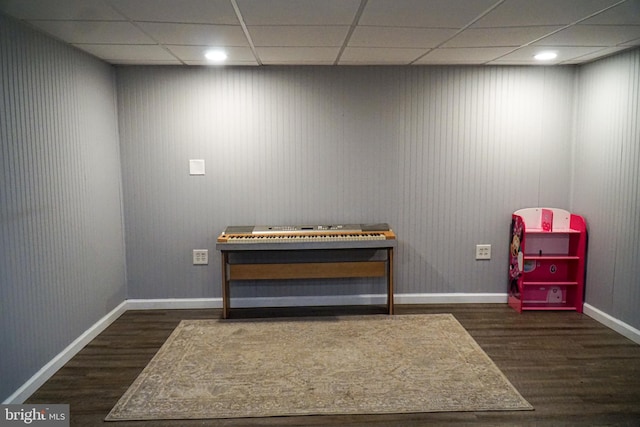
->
106;314;533;421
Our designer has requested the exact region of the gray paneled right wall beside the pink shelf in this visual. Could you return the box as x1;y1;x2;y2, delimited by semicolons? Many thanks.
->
572;49;640;329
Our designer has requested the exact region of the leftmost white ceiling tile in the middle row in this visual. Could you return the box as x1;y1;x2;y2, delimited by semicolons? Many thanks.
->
30;21;155;45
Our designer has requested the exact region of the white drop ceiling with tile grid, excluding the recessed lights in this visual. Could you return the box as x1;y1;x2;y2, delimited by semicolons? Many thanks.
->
0;0;640;66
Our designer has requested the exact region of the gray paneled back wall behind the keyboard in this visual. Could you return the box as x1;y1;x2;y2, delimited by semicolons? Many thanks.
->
117;67;575;298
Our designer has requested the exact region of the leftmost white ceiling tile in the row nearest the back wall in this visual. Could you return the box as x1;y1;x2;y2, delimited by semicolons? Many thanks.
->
75;44;180;64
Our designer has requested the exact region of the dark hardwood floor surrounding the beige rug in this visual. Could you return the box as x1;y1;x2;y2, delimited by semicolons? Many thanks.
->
27;304;640;427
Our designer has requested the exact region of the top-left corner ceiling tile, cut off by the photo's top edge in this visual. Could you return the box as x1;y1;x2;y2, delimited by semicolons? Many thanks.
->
0;0;125;21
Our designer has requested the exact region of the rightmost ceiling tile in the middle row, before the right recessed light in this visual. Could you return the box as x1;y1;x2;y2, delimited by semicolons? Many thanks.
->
535;25;640;46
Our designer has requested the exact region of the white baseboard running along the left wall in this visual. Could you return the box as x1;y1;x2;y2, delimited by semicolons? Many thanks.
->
2;301;127;404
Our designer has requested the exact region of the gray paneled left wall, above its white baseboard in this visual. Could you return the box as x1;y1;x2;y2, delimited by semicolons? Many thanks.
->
0;15;126;401
